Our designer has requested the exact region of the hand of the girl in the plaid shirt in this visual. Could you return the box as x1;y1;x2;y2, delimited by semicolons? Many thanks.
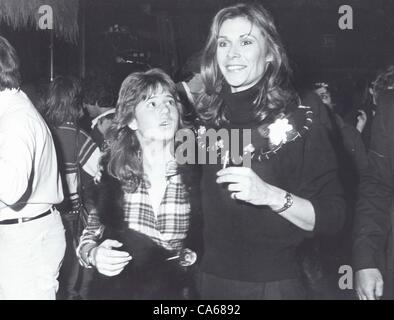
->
91;239;132;277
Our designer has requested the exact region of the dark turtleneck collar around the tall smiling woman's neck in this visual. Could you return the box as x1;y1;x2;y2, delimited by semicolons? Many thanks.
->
221;81;261;126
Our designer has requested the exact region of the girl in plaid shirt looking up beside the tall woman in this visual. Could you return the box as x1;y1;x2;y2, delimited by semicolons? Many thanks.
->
77;69;199;299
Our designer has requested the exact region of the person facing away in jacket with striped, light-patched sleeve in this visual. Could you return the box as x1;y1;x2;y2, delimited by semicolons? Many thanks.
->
45;76;101;300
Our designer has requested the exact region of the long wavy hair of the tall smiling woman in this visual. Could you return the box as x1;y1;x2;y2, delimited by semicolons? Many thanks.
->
197;3;299;125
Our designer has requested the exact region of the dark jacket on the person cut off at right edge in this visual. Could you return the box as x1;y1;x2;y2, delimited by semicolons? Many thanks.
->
353;90;394;295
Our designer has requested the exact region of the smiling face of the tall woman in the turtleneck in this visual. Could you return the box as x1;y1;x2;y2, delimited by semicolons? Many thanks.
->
216;17;272;92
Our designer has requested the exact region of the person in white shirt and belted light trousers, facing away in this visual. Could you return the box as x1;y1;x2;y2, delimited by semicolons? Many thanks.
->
0;37;66;300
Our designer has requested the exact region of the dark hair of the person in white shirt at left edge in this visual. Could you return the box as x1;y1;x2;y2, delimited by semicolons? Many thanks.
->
0;36;21;91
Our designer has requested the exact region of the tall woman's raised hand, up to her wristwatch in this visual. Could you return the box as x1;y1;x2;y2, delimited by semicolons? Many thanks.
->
216;167;286;210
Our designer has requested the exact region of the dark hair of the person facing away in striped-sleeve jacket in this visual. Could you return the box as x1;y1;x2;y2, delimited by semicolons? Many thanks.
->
45;76;83;126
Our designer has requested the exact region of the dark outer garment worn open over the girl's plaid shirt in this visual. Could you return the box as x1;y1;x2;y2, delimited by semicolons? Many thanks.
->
91;168;202;300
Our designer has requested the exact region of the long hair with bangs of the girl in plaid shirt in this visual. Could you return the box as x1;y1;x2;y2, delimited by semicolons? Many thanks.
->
103;69;182;192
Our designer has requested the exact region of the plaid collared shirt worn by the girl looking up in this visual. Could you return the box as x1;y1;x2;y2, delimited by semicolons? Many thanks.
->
77;160;190;266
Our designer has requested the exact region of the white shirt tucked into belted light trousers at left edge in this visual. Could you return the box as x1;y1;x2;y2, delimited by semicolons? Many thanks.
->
0;89;63;220
